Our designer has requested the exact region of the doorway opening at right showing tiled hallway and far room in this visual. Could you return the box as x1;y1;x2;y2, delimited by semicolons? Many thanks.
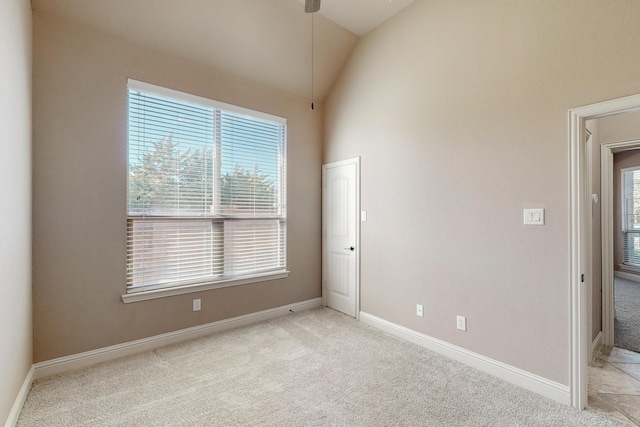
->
587;133;640;422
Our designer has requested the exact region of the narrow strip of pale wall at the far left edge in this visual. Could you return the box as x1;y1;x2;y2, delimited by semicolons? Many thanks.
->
0;0;32;425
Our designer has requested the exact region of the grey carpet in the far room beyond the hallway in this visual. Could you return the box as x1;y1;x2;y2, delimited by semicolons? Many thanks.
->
614;278;640;353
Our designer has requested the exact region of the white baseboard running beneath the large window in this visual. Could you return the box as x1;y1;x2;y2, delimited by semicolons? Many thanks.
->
33;298;322;380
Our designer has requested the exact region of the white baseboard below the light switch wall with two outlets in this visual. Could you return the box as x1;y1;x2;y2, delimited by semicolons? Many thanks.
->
360;311;571;405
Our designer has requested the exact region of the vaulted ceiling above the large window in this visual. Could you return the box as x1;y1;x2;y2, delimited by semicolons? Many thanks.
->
32;0;413;101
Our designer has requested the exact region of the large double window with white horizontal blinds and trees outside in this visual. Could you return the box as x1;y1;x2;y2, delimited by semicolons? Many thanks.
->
123;80;287;302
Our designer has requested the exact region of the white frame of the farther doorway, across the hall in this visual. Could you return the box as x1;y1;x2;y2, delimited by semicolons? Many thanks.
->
600;139;640;346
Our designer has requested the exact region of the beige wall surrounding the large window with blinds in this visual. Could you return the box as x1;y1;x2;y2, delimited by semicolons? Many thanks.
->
33;14;322;362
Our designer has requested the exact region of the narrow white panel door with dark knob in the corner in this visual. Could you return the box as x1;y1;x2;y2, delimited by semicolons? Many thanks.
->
322;158;360;317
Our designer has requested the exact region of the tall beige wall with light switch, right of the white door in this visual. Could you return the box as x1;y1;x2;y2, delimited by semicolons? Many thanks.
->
324;0;640;385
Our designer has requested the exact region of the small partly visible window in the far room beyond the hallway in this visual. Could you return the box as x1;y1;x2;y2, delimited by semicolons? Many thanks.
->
622;167;640;268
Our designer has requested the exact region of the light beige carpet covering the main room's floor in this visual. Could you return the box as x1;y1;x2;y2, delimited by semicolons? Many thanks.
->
18;309;622;426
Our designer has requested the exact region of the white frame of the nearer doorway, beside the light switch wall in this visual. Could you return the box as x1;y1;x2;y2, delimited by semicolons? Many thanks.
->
569;95;640;409
